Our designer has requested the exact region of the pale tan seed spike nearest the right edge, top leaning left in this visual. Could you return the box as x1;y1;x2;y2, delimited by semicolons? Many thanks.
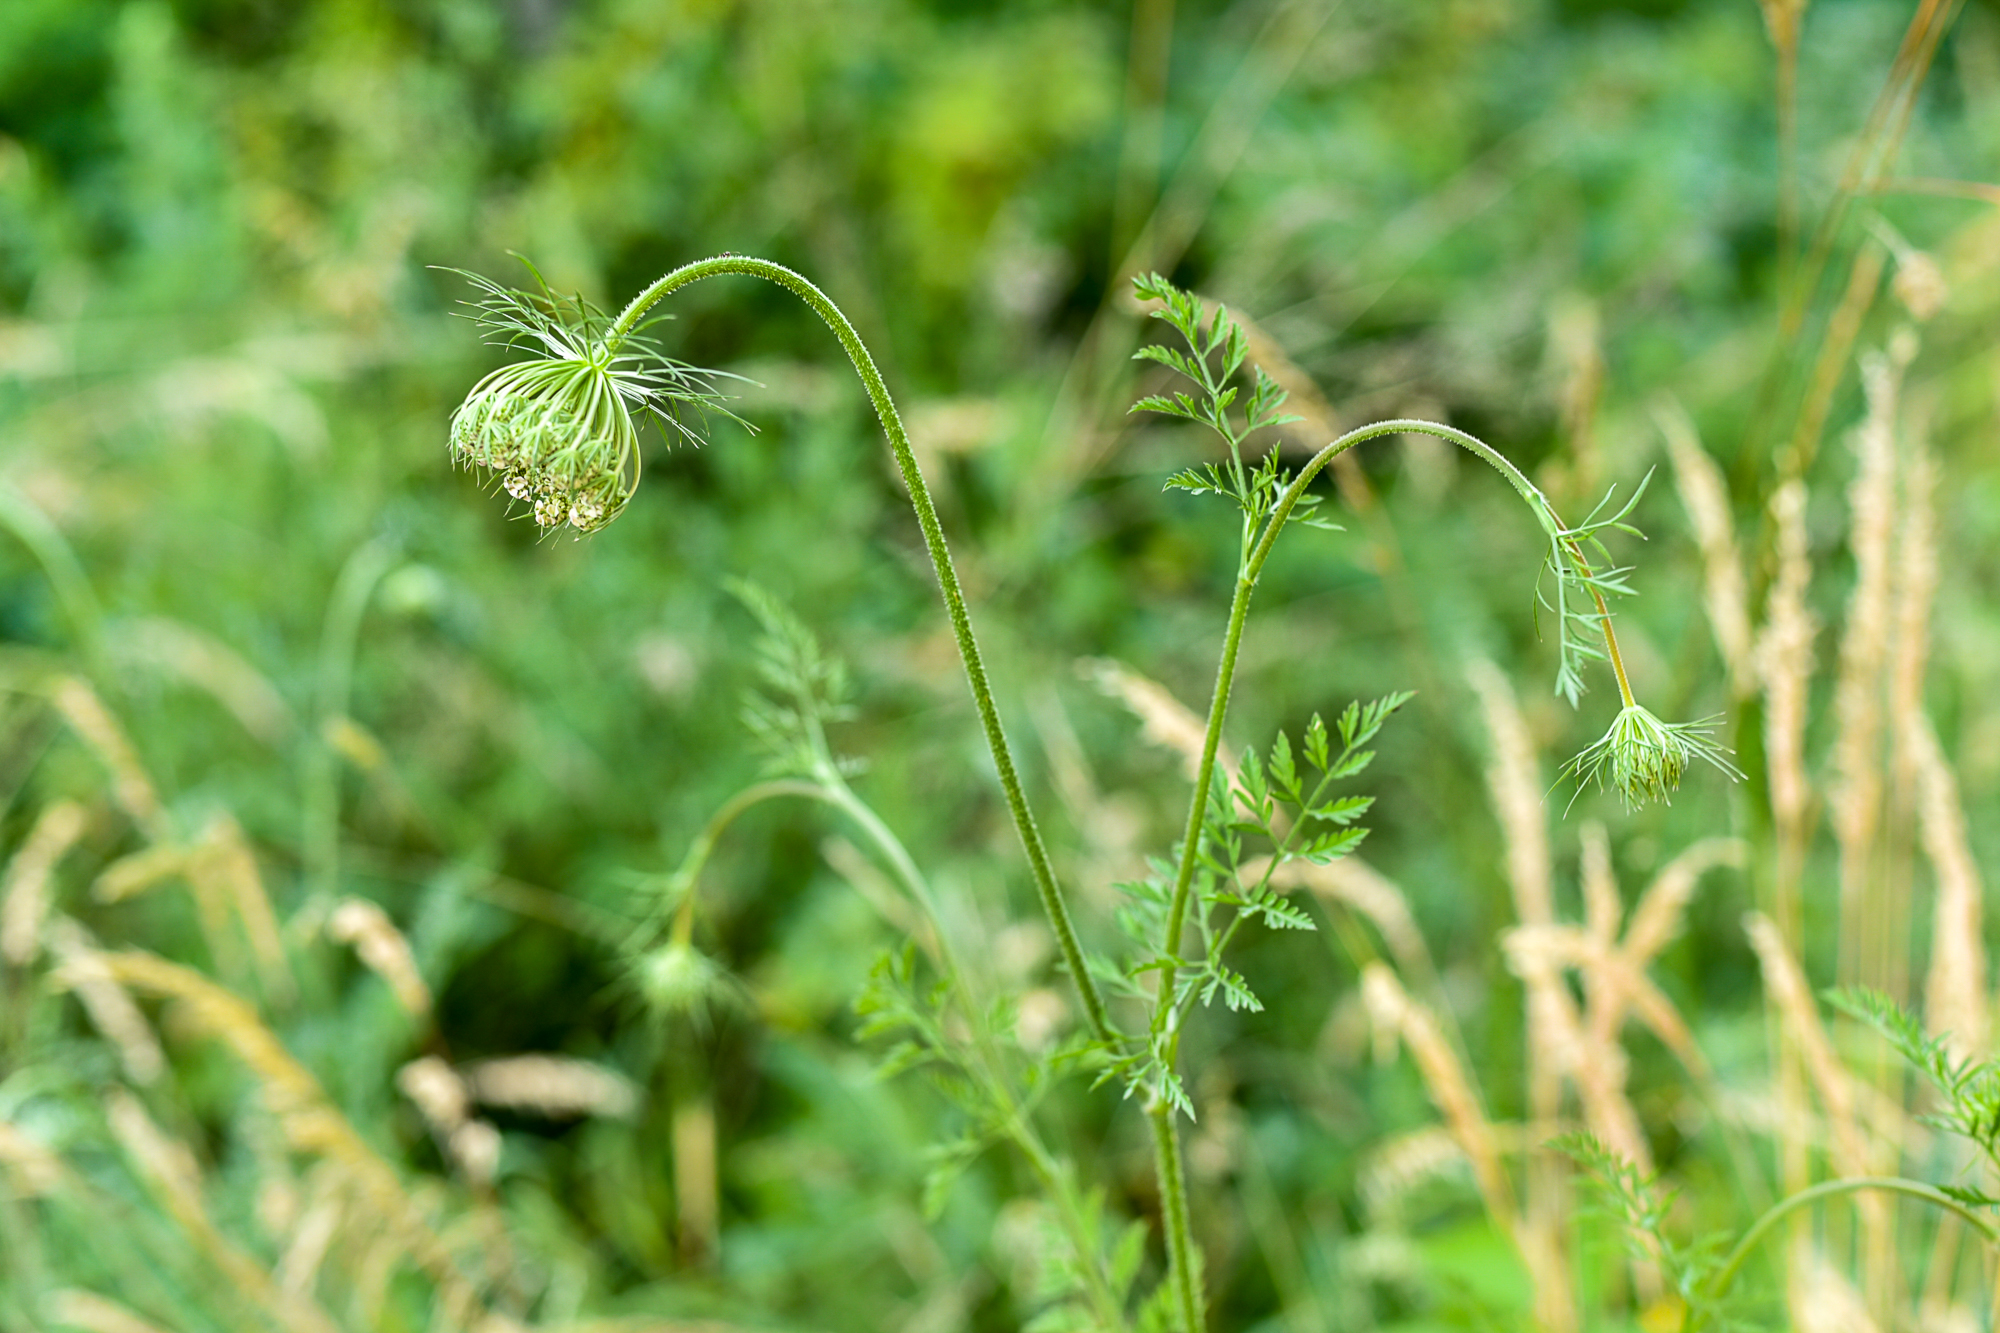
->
1906;717;1990;1059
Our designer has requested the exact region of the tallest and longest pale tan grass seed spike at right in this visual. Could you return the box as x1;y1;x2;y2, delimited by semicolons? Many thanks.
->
1832;352;1898;953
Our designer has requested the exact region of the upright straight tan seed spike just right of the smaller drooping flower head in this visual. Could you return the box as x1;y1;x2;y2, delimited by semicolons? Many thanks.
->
1756;480;1818;849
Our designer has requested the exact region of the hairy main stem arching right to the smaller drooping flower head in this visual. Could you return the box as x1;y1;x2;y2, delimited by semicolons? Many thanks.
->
1152;420;1632;1333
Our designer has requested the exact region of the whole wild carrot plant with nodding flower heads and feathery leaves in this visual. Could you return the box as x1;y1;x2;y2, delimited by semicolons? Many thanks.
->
438;254;1738;1333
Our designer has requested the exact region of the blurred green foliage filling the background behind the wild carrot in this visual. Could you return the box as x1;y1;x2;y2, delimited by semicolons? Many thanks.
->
0;0;2000;1333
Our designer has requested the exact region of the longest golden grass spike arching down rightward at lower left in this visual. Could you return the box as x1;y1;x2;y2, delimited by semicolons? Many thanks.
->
96;953;478;1327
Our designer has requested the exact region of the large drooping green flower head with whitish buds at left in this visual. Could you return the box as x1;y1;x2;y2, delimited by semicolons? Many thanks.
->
452;264;744;532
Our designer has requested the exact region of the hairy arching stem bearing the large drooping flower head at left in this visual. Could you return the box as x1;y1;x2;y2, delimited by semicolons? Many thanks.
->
604;254;1116;1041
